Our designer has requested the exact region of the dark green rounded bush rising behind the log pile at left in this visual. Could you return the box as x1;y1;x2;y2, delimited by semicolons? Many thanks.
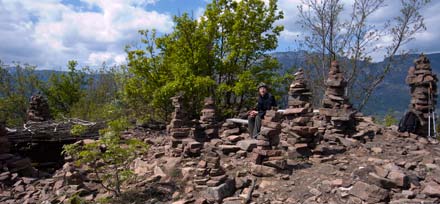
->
43;61;86;116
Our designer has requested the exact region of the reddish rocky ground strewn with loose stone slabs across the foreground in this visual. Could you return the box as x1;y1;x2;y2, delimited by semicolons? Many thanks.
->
0;122;440;204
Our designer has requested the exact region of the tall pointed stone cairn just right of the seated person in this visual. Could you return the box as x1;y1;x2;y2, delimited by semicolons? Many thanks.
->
282;69;318;159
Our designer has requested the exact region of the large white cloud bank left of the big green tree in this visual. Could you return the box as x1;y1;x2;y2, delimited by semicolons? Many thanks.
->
0;0;173;68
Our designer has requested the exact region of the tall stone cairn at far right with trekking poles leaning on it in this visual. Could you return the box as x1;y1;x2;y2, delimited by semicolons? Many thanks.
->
406;54;438;136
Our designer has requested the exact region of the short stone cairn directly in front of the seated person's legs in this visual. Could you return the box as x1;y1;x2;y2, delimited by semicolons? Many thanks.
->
251;110;287;171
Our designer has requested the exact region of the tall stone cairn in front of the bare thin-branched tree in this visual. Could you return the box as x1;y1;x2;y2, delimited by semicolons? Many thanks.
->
319;61;356;140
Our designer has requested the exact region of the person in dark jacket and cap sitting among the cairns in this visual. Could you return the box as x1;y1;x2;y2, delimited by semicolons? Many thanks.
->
248;83;277;139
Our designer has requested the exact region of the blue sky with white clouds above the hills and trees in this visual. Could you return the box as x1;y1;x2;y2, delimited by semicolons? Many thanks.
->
0;0;440;69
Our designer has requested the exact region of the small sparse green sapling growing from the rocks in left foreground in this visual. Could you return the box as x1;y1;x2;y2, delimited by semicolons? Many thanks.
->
63;119;147;196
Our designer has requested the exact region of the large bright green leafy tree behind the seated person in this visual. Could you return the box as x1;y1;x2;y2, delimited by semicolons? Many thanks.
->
125;0;283;120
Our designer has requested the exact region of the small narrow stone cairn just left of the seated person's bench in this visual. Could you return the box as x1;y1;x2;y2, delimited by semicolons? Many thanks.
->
200;98;218;139
